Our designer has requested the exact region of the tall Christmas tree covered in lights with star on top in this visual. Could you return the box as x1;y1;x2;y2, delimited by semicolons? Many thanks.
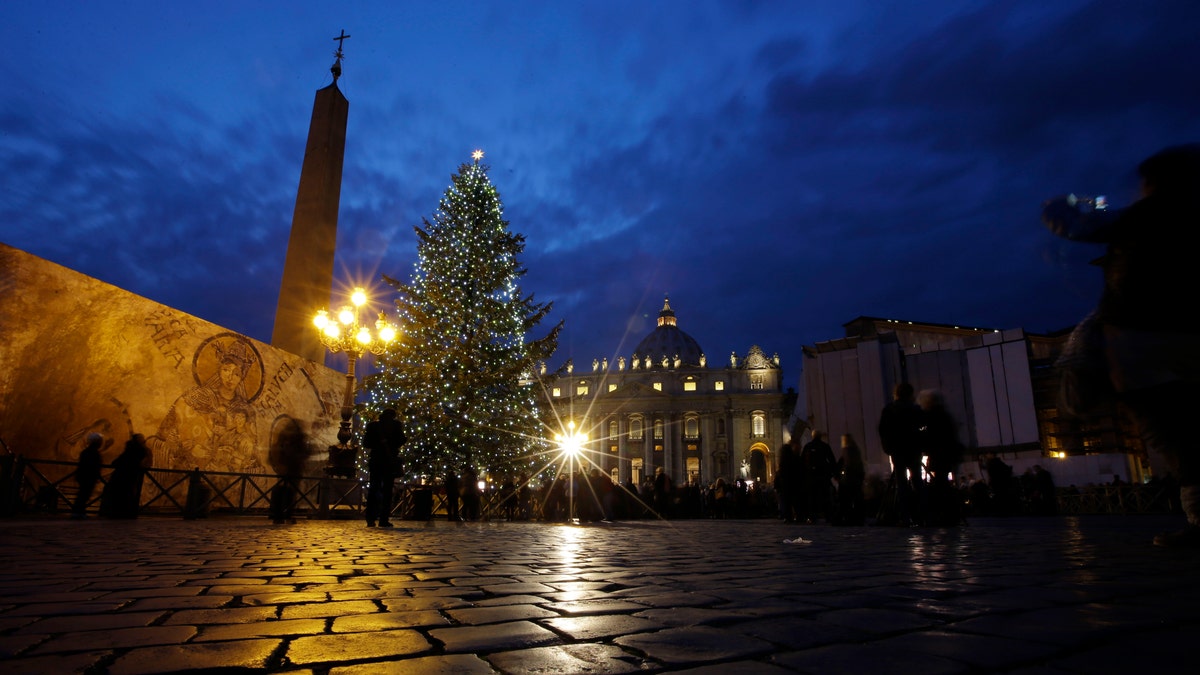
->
367;150;562;479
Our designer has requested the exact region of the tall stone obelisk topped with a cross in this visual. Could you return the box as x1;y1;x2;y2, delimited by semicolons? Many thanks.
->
271;30;350;363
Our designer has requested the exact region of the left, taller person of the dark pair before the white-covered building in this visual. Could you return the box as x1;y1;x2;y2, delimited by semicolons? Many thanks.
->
878;382;925;525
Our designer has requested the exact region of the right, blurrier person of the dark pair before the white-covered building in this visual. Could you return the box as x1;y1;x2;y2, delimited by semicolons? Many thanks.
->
917;389;964;527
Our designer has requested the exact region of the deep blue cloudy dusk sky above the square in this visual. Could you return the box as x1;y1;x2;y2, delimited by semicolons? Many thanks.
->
0;0;1200;386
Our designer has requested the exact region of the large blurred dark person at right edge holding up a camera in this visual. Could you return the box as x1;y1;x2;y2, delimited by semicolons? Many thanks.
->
1043;143;1200;546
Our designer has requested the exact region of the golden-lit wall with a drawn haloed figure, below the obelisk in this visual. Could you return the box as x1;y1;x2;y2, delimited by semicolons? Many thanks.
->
0;244;346;473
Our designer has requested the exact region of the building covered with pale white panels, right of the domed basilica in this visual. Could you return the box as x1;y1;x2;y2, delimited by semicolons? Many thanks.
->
792;317;1159;485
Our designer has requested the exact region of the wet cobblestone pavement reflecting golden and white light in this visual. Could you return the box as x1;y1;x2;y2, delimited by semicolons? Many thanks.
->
0;516;1200;675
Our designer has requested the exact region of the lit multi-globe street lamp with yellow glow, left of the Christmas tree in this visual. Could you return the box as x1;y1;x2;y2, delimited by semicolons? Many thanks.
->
312;286;396;468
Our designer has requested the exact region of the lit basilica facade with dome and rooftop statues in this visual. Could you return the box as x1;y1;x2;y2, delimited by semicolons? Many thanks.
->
542;300;792;485
